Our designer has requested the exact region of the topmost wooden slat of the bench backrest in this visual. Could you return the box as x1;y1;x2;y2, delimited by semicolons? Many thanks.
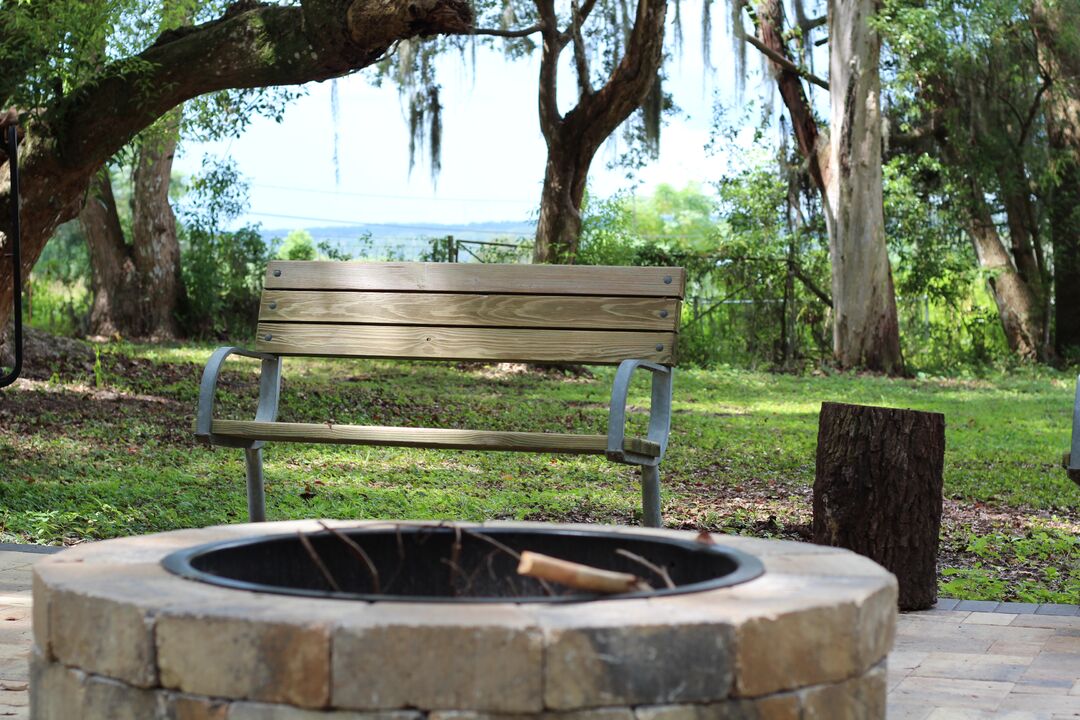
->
264;260;686;298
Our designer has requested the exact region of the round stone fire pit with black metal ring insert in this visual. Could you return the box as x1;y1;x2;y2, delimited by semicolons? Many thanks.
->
30;522;895;720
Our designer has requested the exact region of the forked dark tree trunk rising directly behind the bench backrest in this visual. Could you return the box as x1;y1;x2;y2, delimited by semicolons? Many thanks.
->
532;0;667;262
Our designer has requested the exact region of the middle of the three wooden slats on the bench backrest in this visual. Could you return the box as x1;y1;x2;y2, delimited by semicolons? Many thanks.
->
259;290;679;331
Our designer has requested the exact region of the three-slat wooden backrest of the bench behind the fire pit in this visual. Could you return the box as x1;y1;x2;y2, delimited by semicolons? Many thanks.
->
256;260;686;365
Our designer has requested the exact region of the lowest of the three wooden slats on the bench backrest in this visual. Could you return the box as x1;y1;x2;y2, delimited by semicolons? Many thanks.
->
255;323;676;365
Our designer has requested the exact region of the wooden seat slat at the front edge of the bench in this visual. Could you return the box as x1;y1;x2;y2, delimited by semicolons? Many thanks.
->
203;420;660;457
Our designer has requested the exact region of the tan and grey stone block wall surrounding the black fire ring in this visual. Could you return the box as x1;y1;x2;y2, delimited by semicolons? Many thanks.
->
30;521;896;720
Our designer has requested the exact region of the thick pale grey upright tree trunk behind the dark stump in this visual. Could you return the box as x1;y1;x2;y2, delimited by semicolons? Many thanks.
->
826;0;904;375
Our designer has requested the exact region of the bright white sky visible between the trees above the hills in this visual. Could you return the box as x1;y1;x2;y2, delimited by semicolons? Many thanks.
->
176;3;777;234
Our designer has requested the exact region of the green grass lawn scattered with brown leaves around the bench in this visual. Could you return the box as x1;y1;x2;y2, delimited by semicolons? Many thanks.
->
0;345;1080;603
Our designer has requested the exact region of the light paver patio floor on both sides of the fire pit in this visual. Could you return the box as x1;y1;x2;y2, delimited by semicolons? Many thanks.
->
0;547;1080;720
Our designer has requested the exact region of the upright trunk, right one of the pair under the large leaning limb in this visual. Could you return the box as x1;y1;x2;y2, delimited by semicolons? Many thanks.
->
132;110;184;339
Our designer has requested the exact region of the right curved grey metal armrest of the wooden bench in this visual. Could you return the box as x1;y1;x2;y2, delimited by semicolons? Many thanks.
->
606;359;672;466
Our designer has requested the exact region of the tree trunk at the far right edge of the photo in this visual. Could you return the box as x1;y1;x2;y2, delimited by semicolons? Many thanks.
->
1031;0;1080;357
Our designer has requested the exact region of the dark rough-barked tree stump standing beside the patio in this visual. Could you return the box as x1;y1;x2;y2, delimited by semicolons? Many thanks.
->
813;403;945;610
